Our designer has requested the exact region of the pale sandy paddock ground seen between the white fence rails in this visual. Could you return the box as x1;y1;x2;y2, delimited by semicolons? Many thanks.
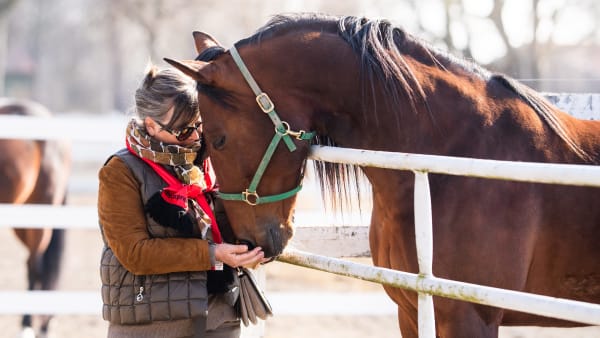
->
0;162;600;338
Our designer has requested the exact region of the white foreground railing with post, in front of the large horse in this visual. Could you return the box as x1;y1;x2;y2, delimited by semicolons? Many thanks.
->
280;147;600;337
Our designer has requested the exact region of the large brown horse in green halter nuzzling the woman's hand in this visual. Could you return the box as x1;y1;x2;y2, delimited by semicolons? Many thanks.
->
169;15;600;338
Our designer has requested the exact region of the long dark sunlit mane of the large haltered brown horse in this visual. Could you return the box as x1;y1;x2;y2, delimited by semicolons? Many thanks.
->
238;13;591;209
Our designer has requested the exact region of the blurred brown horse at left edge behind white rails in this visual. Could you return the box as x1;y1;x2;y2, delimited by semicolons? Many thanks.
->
0;98;71;335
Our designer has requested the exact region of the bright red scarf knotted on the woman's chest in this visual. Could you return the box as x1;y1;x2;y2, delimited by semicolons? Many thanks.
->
126;142;223;243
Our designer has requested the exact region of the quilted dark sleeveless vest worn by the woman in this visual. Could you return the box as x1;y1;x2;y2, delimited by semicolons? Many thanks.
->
100;149;208;325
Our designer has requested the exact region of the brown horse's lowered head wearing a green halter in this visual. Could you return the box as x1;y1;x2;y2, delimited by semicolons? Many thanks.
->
166;32;312;257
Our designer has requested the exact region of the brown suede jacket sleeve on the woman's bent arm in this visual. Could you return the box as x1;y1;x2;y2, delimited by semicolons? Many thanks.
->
98;156;211;275
